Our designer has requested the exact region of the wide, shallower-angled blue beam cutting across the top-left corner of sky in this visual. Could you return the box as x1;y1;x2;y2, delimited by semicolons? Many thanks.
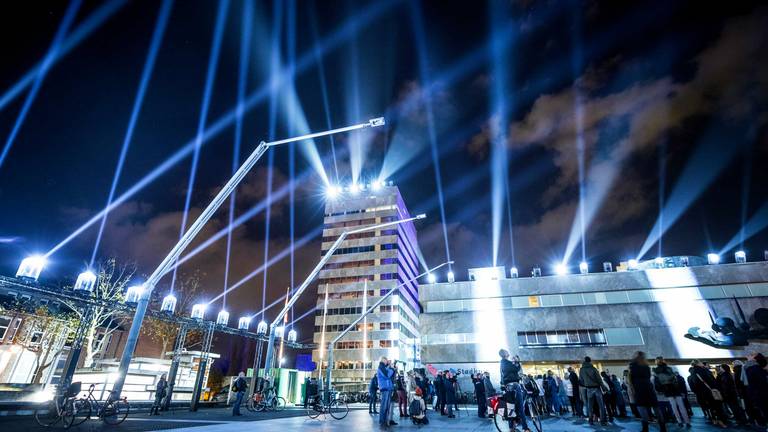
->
0;0;128;110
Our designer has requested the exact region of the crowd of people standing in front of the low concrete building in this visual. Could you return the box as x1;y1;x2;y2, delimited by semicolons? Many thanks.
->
368;349;768;431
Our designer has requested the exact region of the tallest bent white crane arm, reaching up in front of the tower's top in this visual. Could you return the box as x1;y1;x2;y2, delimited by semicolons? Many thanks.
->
112;117;384;400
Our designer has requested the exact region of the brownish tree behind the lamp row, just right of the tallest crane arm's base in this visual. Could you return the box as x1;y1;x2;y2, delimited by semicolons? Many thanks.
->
141;273;200;358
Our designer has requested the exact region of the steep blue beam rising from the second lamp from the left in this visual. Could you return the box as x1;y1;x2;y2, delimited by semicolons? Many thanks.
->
90;0;173;267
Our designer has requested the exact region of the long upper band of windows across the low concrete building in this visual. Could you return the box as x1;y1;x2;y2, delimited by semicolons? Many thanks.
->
425;283;768;313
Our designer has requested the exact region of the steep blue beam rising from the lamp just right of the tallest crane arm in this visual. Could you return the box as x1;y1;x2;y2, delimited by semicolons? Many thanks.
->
171;0;229;292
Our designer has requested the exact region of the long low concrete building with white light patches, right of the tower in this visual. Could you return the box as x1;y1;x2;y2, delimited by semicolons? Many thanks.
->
419;262;768;382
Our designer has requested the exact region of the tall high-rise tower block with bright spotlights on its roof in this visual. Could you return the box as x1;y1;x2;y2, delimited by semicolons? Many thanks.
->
312;186;420;391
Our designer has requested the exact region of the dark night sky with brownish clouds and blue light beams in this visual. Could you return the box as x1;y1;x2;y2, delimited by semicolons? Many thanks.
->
0;0;768;368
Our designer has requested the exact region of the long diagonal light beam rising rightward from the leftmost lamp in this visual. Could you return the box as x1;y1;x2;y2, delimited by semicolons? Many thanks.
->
45;0;401;257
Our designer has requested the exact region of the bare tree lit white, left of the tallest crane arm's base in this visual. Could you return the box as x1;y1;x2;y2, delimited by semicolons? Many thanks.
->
64;258;136;367
